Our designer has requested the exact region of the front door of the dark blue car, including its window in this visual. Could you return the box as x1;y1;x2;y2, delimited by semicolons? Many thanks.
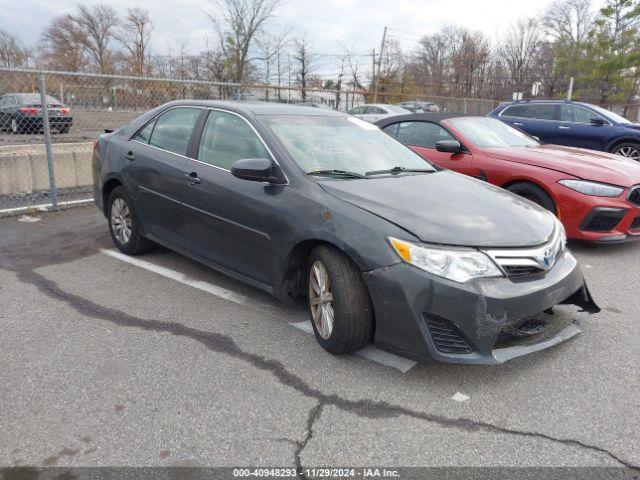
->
555;103;611;150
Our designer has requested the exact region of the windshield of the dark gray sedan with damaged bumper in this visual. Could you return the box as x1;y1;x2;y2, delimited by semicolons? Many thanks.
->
263;115;435;177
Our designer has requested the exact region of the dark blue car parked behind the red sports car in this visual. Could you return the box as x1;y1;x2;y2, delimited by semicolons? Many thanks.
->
489;100;640;161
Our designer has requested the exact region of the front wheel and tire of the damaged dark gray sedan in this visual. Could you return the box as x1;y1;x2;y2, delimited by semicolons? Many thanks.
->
307;246;373;354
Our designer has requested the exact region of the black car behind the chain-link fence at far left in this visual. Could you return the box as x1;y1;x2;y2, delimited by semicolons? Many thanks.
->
0;93;73;133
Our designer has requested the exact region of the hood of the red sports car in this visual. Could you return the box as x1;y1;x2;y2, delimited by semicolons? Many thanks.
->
484;145;640;187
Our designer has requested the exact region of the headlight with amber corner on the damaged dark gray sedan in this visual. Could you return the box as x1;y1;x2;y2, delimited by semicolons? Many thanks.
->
389;238;503;282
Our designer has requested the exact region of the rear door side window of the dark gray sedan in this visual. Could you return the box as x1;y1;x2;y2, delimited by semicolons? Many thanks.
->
149;108;200;155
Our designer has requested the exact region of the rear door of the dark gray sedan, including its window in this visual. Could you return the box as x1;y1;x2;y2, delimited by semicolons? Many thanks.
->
121;107;205;248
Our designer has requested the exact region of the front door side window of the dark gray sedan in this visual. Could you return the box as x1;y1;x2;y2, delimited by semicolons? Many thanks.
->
198;111;271;170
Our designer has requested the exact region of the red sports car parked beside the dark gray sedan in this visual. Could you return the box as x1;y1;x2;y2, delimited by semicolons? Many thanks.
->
376;114;640;243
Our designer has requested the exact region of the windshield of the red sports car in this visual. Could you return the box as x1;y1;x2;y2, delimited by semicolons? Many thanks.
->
447;117;540;148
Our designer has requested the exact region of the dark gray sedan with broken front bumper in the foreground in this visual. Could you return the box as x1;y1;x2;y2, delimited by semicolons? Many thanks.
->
93;101;598;364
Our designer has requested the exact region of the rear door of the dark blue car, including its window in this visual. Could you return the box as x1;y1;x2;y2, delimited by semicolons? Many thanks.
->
500;102;558;143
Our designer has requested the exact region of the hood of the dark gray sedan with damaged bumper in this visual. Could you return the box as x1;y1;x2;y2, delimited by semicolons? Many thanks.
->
319;171;554;247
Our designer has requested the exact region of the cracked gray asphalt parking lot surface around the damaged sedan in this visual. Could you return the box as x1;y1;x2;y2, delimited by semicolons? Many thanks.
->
0;207;640;468
